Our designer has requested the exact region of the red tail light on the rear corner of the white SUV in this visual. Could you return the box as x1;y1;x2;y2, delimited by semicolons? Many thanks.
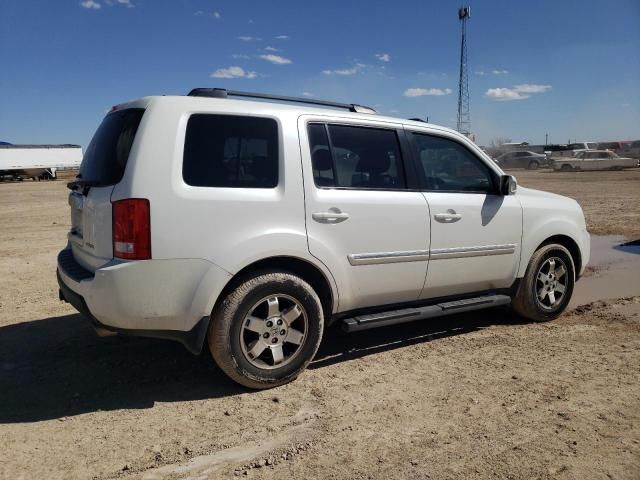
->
112;198;151;260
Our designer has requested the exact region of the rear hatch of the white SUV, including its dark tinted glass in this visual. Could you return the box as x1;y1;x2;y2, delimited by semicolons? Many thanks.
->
68;108;144;271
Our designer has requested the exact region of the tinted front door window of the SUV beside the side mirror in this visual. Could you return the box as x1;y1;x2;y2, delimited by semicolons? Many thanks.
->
413;133;496;193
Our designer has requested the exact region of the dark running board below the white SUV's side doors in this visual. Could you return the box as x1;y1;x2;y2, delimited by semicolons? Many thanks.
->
342;295;511;332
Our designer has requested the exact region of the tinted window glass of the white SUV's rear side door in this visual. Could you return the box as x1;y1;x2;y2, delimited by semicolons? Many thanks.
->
309;125;406;190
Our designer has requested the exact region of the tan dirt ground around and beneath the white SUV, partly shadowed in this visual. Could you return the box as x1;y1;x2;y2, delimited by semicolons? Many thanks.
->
0;171;640;480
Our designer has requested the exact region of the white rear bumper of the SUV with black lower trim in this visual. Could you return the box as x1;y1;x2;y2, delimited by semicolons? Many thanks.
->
57;248;230;352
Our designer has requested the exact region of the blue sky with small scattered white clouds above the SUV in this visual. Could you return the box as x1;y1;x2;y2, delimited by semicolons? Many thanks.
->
0;0;640;146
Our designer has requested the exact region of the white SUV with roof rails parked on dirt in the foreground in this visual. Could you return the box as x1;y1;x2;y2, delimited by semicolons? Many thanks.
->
57;89;589;388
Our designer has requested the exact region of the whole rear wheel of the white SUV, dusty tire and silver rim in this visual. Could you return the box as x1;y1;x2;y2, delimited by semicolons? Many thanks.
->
208;272;324;389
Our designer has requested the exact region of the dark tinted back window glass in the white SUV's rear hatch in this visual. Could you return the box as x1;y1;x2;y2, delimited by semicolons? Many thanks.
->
79;108;144;185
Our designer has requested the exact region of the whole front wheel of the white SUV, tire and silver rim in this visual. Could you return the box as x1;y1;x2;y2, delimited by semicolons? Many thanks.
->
512;243;575;322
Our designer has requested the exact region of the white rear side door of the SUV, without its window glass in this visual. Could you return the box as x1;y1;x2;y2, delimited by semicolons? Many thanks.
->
298;115;429;311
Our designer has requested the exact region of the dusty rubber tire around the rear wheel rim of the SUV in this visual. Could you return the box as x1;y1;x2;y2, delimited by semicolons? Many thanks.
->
208;272;324;389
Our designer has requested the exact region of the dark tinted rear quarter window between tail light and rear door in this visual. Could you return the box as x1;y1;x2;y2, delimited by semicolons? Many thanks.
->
182;114;278;188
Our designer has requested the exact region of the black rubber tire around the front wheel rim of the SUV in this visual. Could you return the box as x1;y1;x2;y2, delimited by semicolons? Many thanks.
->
512;243;576;322
